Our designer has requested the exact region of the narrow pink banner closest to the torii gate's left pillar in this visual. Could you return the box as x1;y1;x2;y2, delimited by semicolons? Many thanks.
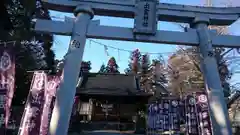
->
40;75;61;135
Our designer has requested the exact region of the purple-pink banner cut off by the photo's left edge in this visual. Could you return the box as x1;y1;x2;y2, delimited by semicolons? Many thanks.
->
0;42;15;132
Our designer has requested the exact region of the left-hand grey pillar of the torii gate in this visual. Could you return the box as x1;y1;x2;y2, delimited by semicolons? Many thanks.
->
49;5;94;135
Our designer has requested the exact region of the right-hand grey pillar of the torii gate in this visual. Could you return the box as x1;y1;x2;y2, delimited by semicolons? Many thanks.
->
192;16;232;135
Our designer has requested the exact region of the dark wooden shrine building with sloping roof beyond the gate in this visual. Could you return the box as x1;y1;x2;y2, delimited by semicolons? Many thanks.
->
70;73;166;133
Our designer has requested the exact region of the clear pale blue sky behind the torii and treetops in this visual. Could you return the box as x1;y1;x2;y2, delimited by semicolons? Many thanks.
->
50;0;239;83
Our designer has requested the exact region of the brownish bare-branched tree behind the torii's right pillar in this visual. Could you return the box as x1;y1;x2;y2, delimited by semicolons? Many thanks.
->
168;0;239;96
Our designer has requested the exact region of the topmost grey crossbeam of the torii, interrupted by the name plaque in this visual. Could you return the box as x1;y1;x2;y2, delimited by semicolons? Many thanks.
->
42;0;240;25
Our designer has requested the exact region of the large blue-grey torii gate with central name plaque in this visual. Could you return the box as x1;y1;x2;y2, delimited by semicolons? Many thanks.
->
35;0;240;135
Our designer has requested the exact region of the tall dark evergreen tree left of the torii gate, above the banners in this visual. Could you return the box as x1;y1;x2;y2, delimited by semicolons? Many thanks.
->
1;0;55;105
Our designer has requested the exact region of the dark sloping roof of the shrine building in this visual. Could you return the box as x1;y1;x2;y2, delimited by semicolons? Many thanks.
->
77;73;152;96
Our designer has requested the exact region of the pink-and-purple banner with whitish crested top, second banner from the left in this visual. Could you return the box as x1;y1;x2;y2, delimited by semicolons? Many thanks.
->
18;71;47;135
